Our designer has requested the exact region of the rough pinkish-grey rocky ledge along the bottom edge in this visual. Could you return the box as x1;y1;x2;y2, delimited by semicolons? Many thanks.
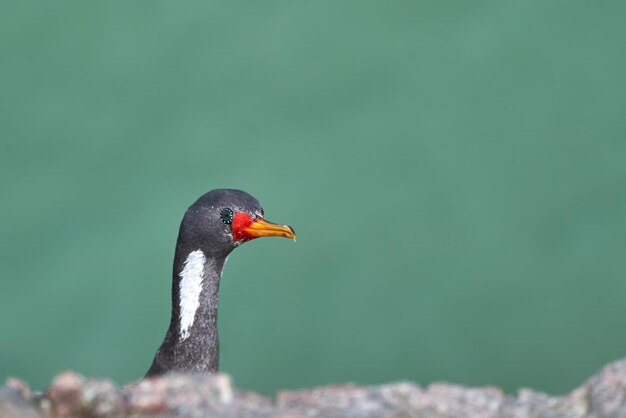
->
0;359;626;418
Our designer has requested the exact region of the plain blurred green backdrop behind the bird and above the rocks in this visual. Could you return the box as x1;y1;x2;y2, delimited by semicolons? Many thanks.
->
0;0;626;393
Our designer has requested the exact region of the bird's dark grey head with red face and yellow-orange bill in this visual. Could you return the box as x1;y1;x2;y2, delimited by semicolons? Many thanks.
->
178;189;295;257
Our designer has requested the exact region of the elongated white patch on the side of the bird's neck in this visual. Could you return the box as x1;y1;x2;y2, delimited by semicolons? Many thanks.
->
178;250;206;341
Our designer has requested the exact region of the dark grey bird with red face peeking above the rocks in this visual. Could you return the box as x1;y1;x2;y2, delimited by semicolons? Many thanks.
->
146;189;296;377
